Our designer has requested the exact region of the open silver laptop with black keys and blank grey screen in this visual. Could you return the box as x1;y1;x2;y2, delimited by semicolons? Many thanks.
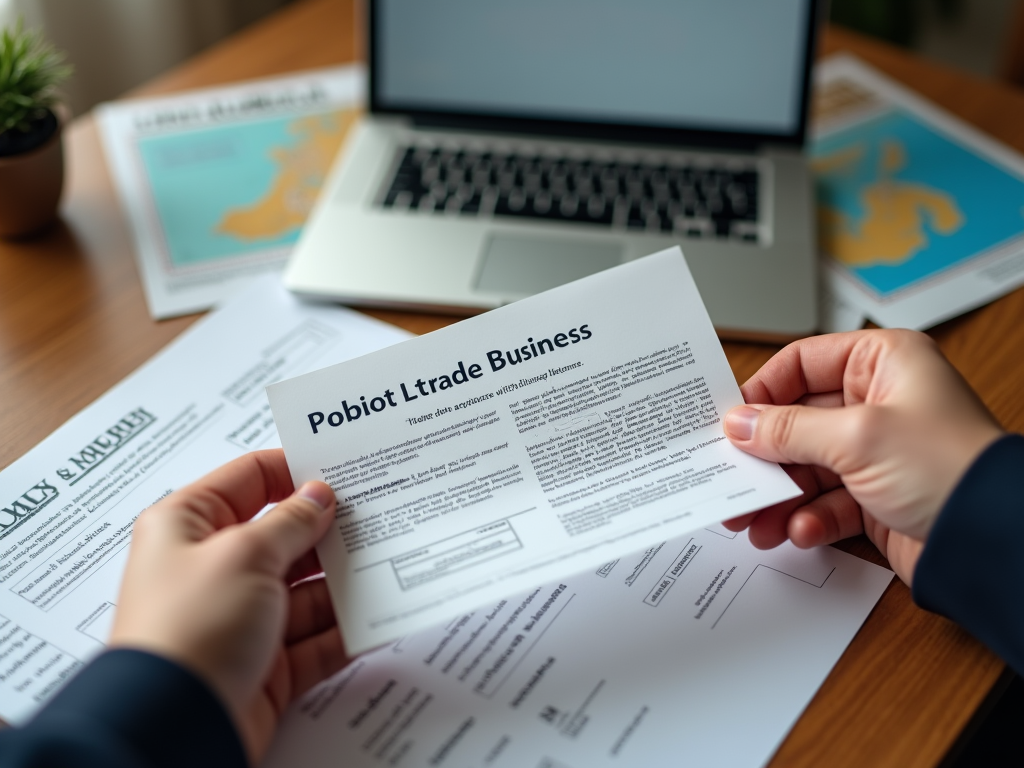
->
285;0;818;341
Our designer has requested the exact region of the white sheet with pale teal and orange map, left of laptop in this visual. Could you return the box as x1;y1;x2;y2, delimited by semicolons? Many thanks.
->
97;66;366;319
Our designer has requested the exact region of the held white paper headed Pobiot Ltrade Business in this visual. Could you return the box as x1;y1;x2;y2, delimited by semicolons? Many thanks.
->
267;248;799;652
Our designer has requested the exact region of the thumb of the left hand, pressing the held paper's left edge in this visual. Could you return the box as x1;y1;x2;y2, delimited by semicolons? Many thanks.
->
247;481;336;575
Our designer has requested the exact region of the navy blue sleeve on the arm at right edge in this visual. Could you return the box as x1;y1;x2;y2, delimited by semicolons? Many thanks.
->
913;434;1024;675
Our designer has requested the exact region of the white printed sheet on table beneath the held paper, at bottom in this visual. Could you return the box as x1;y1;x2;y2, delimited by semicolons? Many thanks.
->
263;526;892;768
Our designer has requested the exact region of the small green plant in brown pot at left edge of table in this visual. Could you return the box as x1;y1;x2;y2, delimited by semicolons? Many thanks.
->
0;22;71;237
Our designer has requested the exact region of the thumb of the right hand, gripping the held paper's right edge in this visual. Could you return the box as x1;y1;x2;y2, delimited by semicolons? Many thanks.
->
724;404;856;473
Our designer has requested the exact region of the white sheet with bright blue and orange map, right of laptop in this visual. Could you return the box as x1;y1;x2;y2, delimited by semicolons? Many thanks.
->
811;55;1024;331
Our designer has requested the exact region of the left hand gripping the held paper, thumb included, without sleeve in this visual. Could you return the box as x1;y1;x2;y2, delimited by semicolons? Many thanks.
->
110;450;347;763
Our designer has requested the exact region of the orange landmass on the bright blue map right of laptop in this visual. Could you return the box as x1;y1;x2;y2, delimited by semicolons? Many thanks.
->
815;140;965;266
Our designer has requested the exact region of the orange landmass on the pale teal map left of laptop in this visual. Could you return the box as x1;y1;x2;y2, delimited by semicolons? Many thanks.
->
216;111;355;241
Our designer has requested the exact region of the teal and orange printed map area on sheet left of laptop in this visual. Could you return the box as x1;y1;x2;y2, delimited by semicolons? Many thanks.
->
139;110;356;268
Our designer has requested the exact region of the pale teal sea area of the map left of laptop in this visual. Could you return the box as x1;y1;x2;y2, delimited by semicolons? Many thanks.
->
139;117;300;266
